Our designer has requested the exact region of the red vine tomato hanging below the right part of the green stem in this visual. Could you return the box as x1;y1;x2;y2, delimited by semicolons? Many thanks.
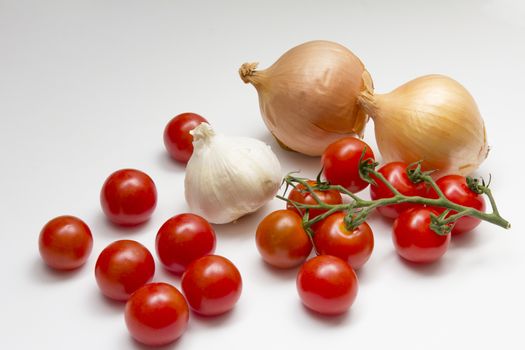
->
392;208;450;263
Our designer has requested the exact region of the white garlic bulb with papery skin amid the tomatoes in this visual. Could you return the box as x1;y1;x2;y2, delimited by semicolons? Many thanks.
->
184;123;281;224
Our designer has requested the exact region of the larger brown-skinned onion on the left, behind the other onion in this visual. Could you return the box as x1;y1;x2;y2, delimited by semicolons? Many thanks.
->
239;41;373;156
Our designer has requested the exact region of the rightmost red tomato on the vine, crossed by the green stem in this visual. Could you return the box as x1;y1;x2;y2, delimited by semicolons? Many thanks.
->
434;175;485;235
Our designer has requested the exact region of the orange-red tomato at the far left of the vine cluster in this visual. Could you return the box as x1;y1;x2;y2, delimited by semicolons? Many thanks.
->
255;210;312;269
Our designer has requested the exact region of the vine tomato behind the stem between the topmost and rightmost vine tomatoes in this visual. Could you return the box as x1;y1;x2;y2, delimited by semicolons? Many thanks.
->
370;162;428;219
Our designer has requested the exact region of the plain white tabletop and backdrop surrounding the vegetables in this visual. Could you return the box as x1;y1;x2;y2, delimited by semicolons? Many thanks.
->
0;0;525;350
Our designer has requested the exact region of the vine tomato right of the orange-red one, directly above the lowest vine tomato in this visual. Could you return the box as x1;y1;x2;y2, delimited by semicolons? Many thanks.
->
314;212;374;269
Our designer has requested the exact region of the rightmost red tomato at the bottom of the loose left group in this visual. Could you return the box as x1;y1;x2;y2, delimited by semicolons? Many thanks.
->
181;255;242;316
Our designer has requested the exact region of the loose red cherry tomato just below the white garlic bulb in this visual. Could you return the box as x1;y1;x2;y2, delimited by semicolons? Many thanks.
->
155;213;216;275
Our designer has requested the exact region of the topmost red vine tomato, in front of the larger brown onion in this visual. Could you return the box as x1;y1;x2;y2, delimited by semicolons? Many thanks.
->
321;137;375;193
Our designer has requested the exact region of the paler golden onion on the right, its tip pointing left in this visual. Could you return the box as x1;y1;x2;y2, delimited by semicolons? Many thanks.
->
360;75;488;177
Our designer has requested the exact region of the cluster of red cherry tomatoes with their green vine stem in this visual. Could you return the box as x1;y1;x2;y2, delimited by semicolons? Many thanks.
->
256;137;510;314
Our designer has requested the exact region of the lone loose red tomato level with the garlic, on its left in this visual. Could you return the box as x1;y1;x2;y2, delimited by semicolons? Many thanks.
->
100;169;157;226
